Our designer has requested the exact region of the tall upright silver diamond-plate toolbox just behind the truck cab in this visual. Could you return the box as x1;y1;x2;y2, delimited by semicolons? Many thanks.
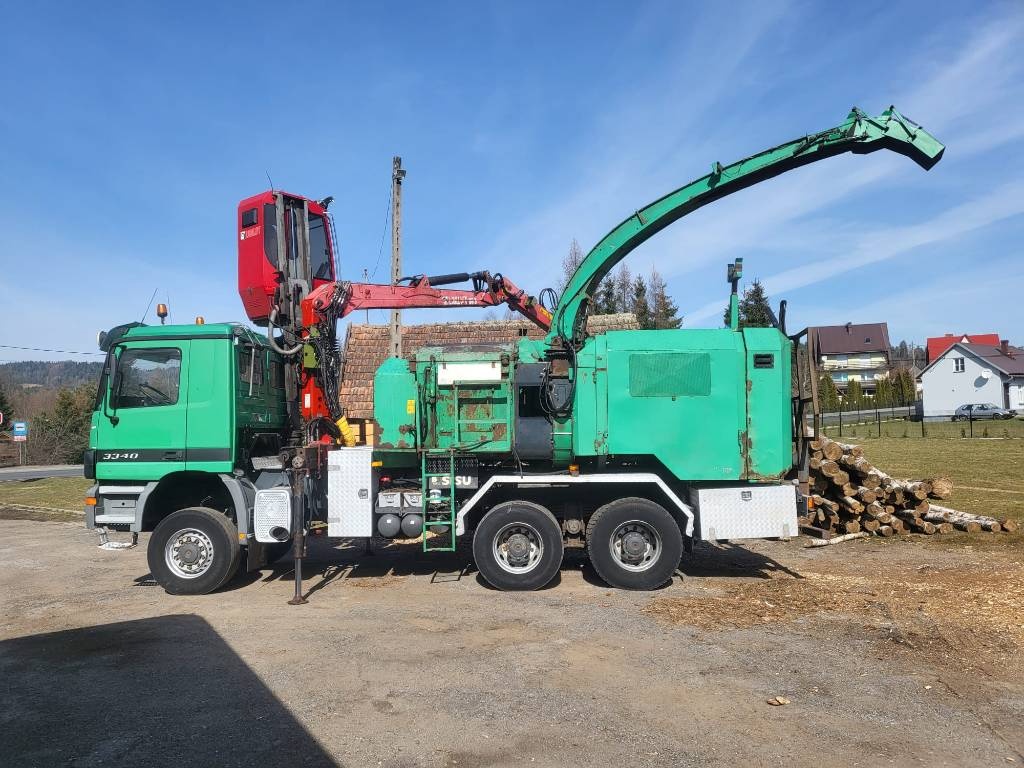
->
327;446;377;537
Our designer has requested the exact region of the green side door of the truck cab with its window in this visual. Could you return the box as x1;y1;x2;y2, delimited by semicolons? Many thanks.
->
95;340;189;480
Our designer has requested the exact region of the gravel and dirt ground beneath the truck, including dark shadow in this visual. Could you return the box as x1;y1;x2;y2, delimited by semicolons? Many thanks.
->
0;519;1024;768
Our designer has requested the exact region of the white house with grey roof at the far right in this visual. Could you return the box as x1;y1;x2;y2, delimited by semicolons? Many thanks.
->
921;341;1024;419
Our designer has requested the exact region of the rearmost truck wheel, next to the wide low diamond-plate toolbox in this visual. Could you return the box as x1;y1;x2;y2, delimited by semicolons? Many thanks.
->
587;498;683;590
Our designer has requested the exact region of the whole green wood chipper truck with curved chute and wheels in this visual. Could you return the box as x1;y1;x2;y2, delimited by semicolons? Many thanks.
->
85;109;943;601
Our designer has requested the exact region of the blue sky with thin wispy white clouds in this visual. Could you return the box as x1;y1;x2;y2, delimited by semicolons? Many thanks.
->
0;2;1024;360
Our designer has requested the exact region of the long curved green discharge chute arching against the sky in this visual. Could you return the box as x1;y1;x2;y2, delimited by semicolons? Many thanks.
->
547;106;945;345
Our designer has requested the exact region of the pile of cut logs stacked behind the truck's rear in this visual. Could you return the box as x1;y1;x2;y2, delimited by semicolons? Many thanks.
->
800;436;1017;539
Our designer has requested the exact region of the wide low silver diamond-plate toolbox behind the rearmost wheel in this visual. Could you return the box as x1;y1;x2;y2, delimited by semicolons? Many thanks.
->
690;484;799;541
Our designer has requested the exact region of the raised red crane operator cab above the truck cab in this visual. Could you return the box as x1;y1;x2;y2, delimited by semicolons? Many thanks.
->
238;190;337;326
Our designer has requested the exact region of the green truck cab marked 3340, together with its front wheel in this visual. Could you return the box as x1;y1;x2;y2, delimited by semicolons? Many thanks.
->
85;324;288;591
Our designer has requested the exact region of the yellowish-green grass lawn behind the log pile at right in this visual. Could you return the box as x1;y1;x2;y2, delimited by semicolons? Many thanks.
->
844;436;1024;522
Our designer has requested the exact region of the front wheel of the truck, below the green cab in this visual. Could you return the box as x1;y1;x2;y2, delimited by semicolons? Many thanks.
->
146;507;241;595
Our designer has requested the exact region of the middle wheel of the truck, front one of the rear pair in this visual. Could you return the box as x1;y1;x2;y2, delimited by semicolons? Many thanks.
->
473;501;563;591
